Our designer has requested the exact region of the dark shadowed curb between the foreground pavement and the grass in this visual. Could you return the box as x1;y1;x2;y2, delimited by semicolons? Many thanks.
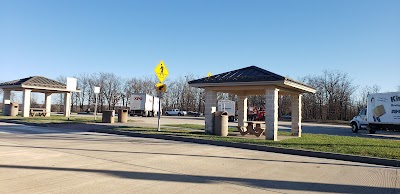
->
90;129;400;167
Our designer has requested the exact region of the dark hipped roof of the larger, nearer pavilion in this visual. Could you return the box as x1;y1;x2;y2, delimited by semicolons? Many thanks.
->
189;66;305;85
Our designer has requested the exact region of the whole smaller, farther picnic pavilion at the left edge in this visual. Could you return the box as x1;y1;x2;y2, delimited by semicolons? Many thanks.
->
0;76;71;117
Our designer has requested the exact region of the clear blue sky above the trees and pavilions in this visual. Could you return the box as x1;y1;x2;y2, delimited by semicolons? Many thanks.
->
0;0;400;92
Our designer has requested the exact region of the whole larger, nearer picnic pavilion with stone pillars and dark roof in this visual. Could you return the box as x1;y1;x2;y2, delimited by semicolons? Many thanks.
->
189;66;316;141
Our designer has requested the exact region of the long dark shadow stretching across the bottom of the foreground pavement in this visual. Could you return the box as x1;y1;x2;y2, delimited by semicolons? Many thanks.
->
0;165;396;193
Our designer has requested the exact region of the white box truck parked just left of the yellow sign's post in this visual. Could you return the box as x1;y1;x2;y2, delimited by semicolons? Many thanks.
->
129;93;160;117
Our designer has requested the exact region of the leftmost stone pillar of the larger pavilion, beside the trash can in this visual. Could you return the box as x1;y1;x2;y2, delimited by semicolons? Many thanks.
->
204;89;217;134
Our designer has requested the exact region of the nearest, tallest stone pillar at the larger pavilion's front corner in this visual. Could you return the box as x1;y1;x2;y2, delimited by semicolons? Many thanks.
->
265;88;279;141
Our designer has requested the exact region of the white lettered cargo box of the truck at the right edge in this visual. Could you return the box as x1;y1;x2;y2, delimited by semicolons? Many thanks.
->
367;92;400;124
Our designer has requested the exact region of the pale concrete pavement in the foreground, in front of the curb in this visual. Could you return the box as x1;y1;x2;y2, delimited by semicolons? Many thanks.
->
0;123;400;193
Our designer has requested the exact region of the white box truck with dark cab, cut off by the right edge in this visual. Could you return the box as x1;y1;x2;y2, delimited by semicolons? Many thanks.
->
350;92;400;133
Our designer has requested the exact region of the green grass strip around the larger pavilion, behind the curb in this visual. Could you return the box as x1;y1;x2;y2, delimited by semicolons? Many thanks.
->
119;125;400;160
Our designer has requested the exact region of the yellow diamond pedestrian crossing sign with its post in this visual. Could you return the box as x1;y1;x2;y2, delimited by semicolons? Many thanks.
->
154;61;168;131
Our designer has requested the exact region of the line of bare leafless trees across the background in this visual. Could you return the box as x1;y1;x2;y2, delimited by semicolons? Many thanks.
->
0;70;400;120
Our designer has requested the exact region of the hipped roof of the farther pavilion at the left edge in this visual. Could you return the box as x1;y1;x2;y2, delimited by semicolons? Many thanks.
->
0;76;67;89
